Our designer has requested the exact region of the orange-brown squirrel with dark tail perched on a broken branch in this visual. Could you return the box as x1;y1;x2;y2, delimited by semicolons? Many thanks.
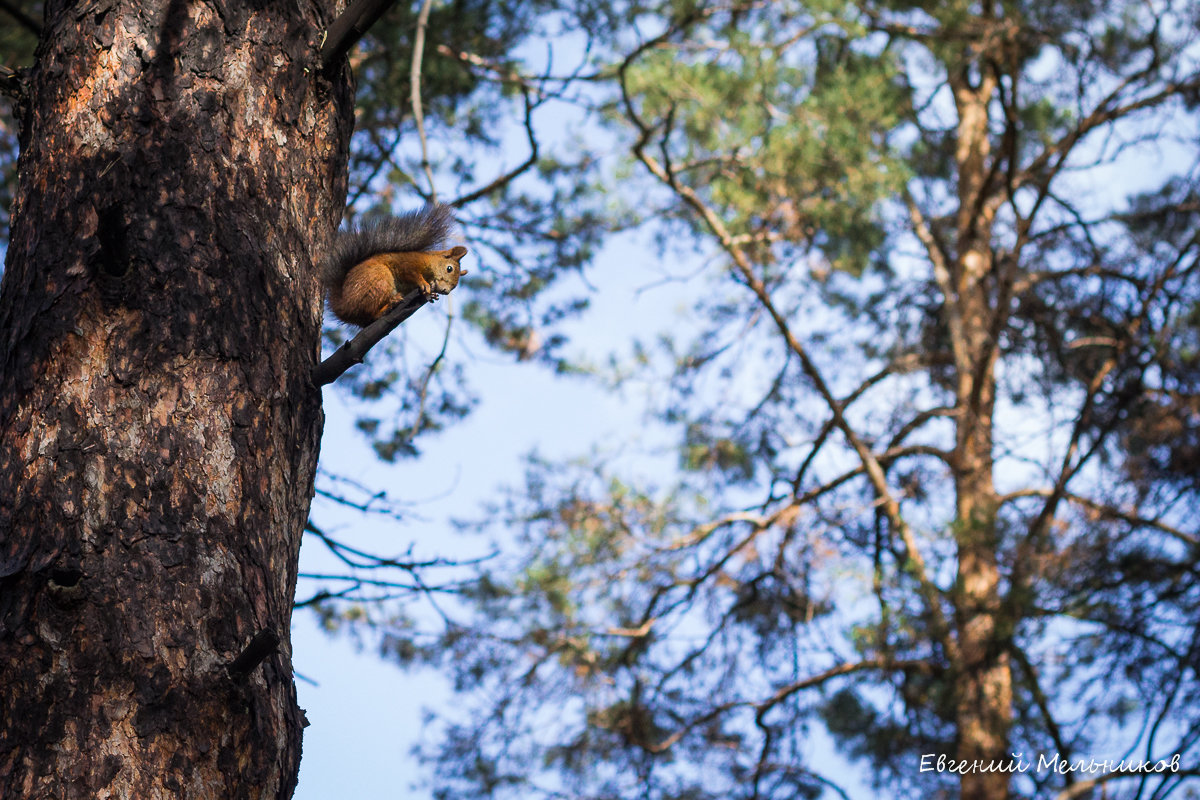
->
320;204;467;326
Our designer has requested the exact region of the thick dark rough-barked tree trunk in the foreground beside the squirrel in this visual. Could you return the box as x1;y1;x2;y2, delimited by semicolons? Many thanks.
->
0;0;352;800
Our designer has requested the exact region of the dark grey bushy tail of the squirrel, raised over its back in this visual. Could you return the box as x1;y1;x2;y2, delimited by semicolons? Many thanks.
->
320;203;454;287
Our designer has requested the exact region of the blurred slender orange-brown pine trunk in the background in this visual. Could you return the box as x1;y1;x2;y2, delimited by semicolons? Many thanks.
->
946;71;1013;800
